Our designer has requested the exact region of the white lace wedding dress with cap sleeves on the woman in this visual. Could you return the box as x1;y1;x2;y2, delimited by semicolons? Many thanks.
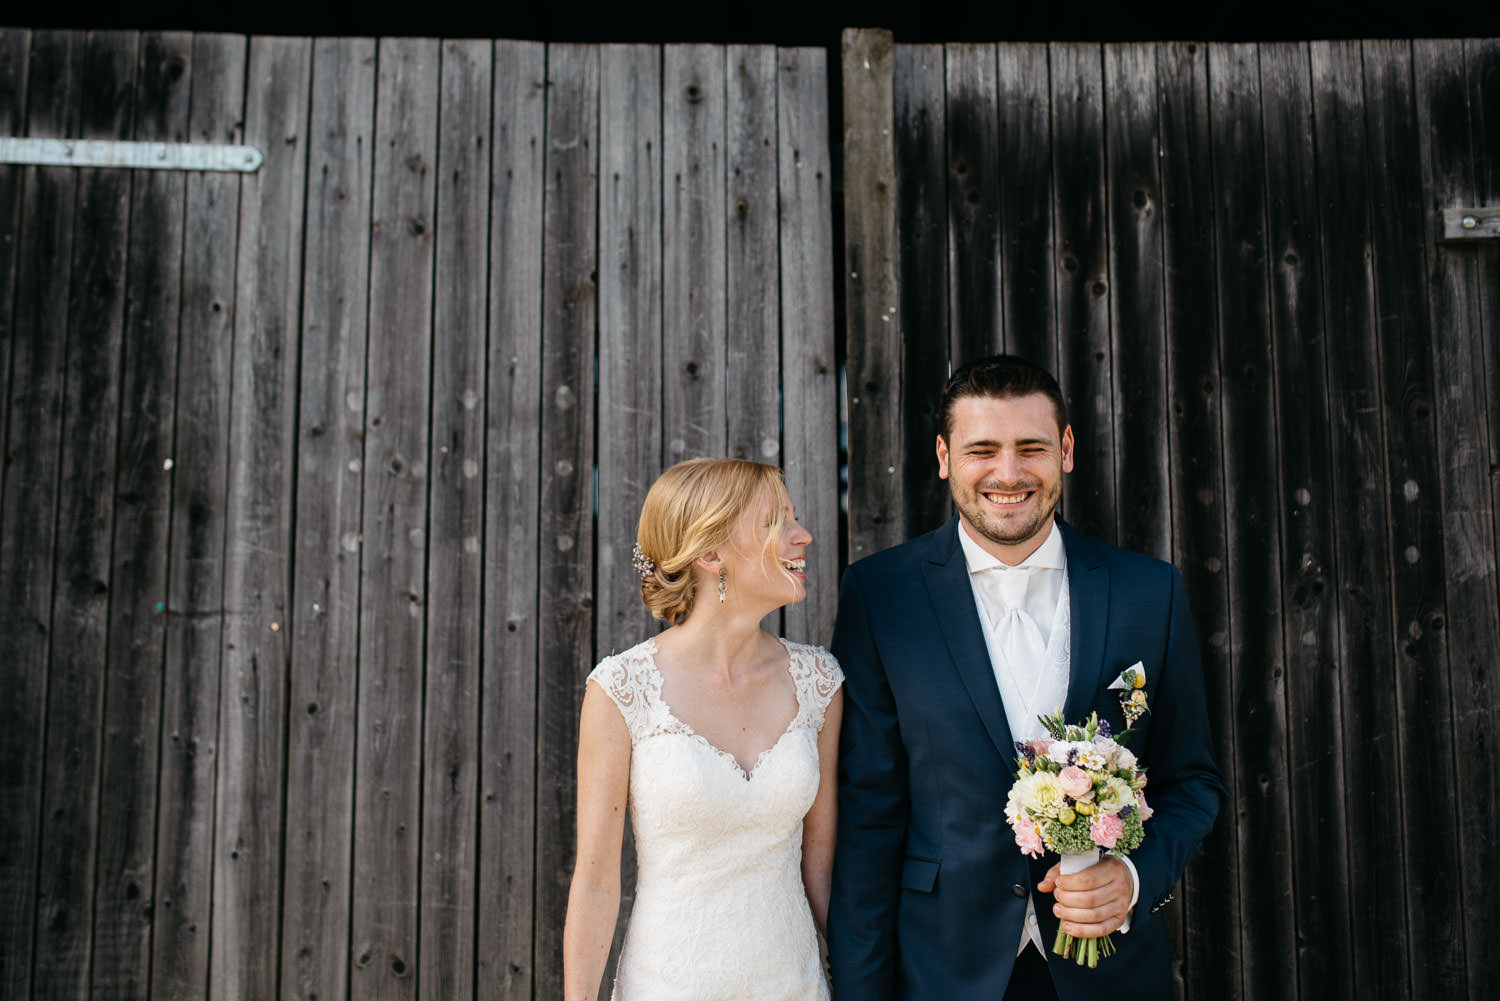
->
588;639;843;1001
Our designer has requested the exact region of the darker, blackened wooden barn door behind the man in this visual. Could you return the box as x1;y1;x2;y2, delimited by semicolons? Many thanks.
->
843;32;1500;1001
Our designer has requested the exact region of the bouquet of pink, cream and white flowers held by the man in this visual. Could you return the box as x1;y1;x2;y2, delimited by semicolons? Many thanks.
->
1005;710;1152;966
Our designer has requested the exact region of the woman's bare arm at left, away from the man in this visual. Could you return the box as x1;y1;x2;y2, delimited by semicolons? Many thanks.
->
563;683;630;1001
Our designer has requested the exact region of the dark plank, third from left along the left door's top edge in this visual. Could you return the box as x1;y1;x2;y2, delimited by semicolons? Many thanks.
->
35;32;137;998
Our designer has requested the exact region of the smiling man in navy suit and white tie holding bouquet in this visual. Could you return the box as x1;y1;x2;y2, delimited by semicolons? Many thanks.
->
828;356;1223;1001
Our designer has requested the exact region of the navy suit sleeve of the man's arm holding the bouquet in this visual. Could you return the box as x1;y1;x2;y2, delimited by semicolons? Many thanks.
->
1131;567;1224;924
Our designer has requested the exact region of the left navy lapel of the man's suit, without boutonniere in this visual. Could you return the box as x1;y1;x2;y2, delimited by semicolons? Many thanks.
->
923;518;1016;761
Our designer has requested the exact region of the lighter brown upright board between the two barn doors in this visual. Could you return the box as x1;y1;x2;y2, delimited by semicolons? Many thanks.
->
843;29;906;561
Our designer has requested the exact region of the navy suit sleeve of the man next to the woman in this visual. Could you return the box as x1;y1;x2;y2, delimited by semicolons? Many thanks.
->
828;567;911;1001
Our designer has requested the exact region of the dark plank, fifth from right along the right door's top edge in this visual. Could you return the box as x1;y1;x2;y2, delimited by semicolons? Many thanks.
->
1260;44;1359;1001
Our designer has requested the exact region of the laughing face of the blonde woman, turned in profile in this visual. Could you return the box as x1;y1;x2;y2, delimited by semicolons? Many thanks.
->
722;486;813;608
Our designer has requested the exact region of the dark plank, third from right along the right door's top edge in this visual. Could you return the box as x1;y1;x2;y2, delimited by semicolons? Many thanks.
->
1364;42;1464;998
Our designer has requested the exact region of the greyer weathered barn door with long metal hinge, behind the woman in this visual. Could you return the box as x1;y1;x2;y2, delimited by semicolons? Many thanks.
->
0;30;839;1001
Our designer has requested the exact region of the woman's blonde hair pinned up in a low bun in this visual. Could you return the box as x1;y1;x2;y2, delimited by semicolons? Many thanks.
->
636;459;786;624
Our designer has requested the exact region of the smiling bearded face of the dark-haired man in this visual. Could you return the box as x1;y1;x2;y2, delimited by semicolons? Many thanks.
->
938;393;1073;566
